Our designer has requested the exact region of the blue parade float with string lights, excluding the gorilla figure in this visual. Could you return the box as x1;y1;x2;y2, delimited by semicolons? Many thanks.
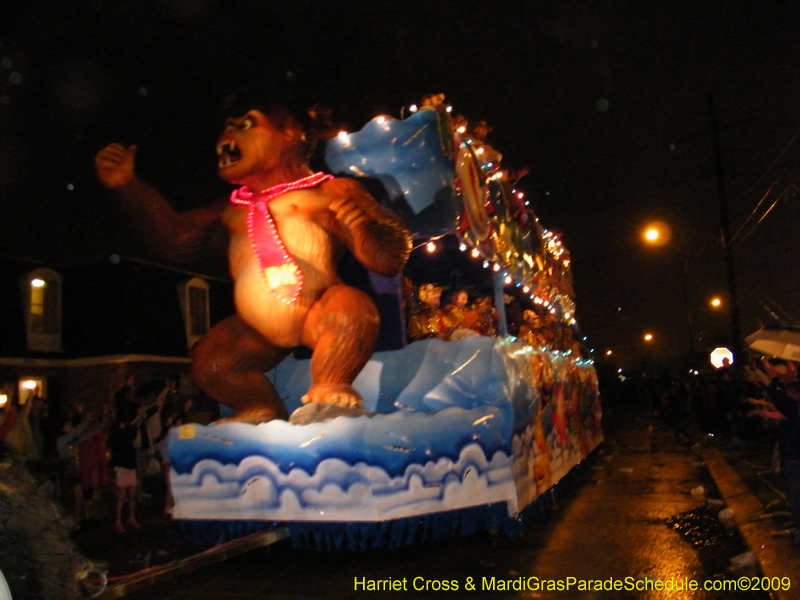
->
152;96;602;549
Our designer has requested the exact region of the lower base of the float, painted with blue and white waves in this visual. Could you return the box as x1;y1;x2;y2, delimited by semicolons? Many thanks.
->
169;336;602;523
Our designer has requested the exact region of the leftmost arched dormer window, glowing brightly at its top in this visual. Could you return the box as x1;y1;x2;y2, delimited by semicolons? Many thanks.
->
24;268;61;352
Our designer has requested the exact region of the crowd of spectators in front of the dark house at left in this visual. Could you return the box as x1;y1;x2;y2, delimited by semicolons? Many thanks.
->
0;376;198;534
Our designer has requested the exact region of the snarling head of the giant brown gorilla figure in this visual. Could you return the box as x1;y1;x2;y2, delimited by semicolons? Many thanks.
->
217;110;302;185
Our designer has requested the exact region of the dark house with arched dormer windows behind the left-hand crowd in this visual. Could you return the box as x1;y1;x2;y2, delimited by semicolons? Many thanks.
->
0;255;234;418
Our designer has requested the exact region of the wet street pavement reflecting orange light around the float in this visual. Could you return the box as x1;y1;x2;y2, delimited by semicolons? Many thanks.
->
112;400;797;600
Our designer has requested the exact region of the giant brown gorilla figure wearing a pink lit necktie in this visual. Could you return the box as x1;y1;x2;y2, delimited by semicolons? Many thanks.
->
95;92;411;423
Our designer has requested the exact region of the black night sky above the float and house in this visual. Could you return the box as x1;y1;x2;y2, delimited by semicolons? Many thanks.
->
0;0;800;363
